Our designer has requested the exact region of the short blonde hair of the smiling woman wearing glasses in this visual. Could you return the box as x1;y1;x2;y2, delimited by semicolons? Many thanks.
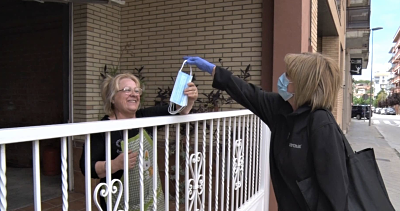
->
101;73;140;115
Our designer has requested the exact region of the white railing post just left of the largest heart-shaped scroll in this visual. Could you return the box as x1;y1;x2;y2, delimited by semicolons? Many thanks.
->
85;134;92;211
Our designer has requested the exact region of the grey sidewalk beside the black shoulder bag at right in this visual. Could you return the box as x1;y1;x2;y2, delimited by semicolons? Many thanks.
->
346;121;400;210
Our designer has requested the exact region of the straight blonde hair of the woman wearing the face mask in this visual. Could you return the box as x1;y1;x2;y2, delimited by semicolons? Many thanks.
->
284;53;343;110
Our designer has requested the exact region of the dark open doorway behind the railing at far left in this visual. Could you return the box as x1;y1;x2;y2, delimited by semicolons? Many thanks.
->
0;0;69;208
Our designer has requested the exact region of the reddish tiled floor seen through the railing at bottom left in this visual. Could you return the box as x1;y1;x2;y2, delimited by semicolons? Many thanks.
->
16;192;86;211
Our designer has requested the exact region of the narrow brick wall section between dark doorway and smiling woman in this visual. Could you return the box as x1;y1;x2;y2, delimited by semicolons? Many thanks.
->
73;4;121;122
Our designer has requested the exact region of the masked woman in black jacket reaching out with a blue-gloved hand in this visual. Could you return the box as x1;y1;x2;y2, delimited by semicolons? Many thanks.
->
184;53;348;211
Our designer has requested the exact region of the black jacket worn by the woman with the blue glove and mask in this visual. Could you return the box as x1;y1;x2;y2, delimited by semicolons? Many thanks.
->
213;67;348;211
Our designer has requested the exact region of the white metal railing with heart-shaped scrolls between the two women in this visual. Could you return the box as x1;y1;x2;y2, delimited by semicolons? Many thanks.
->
0;110;270;211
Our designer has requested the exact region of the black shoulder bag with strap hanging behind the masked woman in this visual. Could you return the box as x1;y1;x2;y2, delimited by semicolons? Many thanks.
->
309;109;394;211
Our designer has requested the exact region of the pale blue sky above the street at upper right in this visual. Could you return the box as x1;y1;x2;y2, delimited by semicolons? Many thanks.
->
353;0;400;80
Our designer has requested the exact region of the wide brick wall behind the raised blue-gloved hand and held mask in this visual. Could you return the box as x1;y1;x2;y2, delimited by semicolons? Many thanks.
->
121;0;262;111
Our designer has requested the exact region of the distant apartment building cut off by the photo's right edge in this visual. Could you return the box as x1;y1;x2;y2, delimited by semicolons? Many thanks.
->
389;27;400;93
